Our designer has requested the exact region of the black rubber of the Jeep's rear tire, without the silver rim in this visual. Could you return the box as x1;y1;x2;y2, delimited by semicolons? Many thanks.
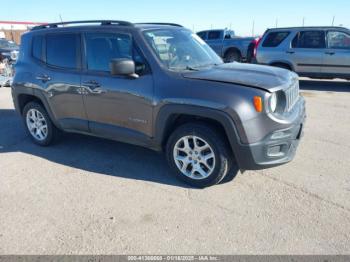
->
22;102;59;146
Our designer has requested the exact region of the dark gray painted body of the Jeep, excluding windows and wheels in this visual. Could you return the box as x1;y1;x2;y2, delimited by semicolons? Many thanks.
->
12;22;304;169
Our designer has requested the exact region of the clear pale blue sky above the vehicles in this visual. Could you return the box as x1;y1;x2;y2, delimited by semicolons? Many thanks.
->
0;0;350;36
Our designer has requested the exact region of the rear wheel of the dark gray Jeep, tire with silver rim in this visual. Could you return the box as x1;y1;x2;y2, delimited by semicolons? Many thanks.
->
22;102;59;146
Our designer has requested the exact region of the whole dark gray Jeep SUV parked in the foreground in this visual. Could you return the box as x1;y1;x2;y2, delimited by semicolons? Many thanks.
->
12;21;305;187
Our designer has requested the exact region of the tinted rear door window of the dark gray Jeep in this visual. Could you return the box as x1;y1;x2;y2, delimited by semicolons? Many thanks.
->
46;34;80;69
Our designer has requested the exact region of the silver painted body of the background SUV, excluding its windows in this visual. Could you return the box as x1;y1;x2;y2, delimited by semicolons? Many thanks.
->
256;27;350;78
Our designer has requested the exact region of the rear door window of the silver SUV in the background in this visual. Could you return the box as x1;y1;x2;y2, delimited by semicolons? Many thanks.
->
292;31;326;48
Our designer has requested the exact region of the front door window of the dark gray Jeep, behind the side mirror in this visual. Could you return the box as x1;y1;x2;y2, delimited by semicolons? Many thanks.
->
85;33;133;72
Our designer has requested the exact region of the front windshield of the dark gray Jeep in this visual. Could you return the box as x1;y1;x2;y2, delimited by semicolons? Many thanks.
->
144;29;223;71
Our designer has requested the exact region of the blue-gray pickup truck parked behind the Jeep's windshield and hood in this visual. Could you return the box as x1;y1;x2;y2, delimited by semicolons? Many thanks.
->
197;29;255;63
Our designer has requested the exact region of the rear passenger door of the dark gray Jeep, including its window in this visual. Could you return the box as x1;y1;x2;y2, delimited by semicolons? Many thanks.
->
32;32;88;131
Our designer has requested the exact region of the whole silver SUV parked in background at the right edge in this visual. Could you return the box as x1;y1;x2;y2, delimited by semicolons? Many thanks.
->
256;27;350;79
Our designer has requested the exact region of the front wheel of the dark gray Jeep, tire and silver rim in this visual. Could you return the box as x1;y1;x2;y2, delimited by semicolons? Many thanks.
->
166;123;232;188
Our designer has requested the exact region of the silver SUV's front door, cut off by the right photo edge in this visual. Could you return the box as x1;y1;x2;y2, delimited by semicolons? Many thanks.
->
322;30;350;76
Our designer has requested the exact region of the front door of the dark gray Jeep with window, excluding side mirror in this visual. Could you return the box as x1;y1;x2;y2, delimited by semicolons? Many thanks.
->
82;31;153;143
